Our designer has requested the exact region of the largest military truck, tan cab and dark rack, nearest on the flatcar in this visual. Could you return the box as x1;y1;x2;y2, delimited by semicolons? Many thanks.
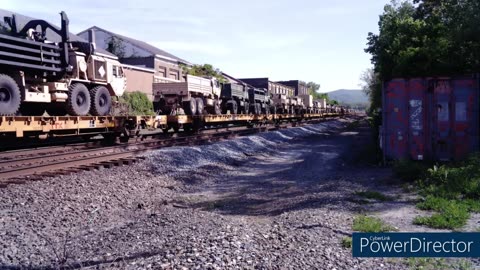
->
0;11;126;116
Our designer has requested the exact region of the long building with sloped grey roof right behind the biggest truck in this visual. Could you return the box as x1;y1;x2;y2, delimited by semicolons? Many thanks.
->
78;26;191;98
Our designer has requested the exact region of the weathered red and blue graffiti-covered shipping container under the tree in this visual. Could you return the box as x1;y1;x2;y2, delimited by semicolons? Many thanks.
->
381;76;479;160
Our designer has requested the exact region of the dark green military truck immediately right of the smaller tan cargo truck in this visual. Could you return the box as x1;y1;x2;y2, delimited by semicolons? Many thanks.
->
220;83;250;114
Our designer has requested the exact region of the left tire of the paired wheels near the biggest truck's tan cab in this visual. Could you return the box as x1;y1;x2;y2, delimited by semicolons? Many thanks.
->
66;83;90;116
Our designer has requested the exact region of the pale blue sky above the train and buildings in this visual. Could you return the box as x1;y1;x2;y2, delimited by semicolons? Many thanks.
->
1;0;389;92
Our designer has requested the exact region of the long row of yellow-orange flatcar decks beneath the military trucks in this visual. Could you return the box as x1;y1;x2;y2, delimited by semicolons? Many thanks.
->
0;113;338;138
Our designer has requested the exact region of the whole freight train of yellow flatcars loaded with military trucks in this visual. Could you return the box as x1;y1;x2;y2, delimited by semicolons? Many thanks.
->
0;12;348;142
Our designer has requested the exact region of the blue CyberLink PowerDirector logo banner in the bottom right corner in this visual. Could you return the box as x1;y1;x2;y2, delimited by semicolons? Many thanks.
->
352;233;480;257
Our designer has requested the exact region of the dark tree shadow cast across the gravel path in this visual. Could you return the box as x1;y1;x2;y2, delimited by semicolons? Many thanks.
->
189;119;394;216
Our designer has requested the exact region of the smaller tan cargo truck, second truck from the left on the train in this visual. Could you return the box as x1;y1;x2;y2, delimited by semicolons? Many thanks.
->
153;75;222;115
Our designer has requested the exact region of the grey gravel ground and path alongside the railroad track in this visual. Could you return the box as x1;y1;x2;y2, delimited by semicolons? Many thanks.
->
0;120;405;269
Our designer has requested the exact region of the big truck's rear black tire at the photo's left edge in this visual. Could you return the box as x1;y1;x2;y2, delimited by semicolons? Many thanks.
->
0;74;22;115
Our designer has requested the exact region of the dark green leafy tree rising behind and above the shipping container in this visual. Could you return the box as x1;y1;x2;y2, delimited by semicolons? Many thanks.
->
362;0;480;123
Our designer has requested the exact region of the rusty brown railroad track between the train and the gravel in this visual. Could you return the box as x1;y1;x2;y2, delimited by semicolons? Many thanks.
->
0;118;334;188
